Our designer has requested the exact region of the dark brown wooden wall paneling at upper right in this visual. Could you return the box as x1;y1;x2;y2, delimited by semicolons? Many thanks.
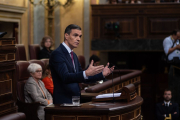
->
92;3;180;39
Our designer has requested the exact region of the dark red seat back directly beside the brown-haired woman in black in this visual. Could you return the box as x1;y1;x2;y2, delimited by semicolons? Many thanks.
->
29;44;40;60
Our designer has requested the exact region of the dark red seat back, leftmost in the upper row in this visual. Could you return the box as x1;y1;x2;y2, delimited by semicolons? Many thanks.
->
16;44;26;61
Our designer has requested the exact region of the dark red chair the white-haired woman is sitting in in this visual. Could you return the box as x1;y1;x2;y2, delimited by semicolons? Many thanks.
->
16;61;40;120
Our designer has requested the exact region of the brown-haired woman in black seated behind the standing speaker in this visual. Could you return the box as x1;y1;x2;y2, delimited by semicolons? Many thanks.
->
39;36;52;59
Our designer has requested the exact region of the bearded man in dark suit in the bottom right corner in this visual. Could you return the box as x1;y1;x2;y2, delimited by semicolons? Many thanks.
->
156;89;179;120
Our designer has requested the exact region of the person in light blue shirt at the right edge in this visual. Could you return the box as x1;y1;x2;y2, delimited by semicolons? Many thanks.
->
163;30;180;61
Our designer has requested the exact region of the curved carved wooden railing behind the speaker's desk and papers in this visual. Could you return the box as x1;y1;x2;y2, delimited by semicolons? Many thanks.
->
85;70;142;96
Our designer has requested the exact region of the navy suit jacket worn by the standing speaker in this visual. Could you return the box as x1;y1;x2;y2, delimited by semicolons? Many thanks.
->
49;44;104;104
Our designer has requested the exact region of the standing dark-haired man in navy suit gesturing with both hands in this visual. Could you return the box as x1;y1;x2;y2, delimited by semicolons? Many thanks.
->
49;24;114;104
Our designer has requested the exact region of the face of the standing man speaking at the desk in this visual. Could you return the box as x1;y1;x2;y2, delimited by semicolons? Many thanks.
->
64;29;82;50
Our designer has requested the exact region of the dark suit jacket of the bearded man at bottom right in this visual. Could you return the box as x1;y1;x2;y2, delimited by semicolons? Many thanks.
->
156;102;179;120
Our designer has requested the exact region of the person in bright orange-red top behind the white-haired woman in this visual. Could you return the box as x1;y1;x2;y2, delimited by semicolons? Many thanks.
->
42;64;54;94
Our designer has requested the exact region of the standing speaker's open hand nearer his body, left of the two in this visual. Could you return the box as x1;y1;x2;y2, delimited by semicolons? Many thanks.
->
85;60;104;77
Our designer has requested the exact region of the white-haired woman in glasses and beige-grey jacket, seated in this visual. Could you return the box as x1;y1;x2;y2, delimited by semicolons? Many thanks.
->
24;63;52;120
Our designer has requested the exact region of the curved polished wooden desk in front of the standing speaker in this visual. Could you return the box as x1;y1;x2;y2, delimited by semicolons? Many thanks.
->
45;96;143;120
